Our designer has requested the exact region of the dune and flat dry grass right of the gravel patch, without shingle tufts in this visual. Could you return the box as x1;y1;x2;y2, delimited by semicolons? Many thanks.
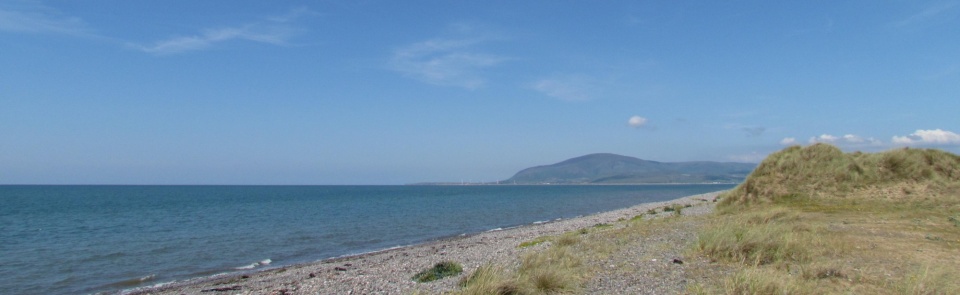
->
689;144;960;294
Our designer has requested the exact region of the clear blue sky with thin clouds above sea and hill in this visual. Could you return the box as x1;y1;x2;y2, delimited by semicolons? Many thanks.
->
0;0;960;185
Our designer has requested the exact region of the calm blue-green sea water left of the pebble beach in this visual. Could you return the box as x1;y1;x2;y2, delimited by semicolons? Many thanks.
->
0;185;733;294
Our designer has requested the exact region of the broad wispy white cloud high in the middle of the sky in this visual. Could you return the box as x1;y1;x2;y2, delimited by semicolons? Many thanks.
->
390;28;507;89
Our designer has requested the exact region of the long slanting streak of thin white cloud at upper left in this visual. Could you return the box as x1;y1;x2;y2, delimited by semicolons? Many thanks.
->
130;8;312;55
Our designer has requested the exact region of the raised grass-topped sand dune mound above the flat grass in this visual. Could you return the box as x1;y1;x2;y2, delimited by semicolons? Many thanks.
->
721;144;960;209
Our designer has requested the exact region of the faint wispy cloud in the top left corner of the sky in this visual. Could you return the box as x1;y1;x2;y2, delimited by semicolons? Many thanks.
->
0;6;92;36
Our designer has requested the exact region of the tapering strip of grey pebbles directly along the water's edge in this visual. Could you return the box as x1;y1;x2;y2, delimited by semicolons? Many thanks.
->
124;191;723;294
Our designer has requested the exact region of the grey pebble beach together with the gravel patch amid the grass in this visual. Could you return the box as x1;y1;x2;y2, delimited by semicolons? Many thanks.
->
122;192;720;294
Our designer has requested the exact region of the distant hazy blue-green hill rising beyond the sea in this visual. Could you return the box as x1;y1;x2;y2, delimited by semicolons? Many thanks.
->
503;154;757;184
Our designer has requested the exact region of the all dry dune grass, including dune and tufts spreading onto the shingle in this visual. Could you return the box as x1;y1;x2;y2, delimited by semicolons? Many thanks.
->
460;144;960;294
